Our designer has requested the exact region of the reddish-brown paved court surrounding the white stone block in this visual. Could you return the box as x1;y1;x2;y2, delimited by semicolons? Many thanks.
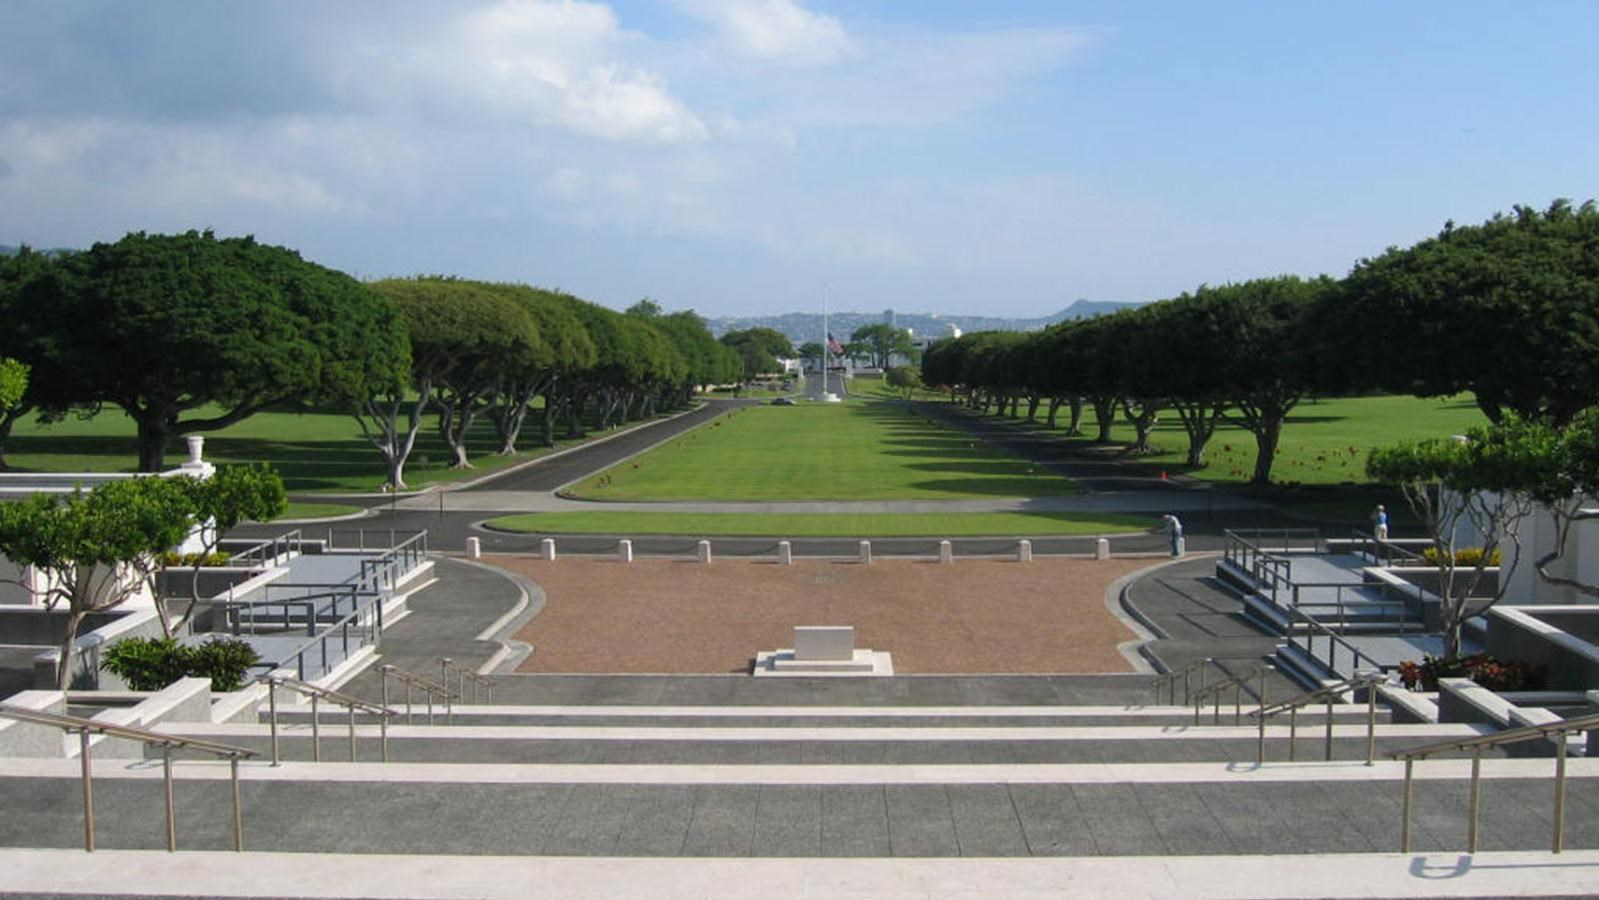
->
484;556;1161;675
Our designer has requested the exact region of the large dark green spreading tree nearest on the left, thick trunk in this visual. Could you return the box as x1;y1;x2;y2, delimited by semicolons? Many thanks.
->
11;232;405;472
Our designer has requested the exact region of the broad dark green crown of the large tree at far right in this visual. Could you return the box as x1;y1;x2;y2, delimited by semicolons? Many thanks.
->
1321;200;1599;424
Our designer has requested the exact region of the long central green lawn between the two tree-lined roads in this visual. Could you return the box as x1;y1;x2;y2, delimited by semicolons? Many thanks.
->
572;400;1076;500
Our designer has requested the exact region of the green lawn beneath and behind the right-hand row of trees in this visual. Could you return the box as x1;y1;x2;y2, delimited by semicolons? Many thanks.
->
984;396;1487;484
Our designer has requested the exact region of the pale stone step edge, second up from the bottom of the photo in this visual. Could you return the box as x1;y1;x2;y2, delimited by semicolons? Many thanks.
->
0;758;1599;790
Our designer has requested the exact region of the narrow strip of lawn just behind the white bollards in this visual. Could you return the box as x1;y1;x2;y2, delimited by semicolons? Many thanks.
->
488;512;1159;537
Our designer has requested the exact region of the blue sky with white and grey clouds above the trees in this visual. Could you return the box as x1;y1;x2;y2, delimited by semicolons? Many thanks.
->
0;0;1599;317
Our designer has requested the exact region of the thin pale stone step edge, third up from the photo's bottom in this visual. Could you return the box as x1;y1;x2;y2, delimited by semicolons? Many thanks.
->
155;721;1477;745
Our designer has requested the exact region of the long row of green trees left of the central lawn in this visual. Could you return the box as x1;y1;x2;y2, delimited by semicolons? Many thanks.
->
0;232;739;488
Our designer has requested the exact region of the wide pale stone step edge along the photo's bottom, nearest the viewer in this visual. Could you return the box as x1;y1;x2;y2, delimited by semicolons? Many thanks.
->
0;849;1599;900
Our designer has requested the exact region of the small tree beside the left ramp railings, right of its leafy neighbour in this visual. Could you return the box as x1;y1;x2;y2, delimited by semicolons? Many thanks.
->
155;465;288;638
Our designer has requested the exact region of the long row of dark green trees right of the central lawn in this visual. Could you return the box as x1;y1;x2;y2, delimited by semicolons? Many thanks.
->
923;200;1599;483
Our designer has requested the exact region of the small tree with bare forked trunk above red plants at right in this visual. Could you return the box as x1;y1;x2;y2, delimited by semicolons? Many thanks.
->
1366;416;1557;657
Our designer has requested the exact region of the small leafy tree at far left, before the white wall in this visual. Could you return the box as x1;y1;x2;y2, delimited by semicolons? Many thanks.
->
0;478;193;691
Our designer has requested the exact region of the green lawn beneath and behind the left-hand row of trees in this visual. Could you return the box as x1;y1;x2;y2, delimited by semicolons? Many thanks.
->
6;409;639;492
